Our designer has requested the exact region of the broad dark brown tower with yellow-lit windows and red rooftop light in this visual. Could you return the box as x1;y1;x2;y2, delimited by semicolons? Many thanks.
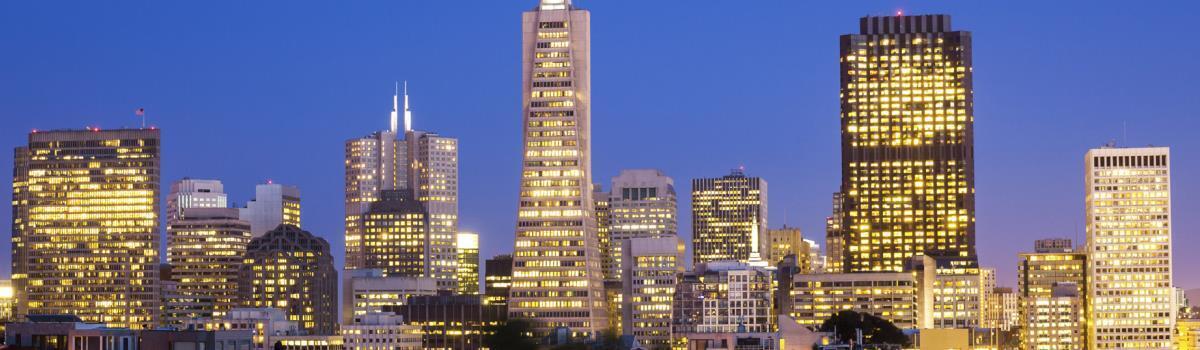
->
840;14;976;272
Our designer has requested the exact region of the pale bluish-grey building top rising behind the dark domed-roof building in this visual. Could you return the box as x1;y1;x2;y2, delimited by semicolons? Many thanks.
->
239;181;300;237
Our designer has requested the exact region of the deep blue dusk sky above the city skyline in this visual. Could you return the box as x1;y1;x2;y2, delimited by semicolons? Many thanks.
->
0;0;1200;288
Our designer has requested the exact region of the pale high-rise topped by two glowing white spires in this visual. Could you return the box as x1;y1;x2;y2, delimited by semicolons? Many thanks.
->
346;84;458;290
